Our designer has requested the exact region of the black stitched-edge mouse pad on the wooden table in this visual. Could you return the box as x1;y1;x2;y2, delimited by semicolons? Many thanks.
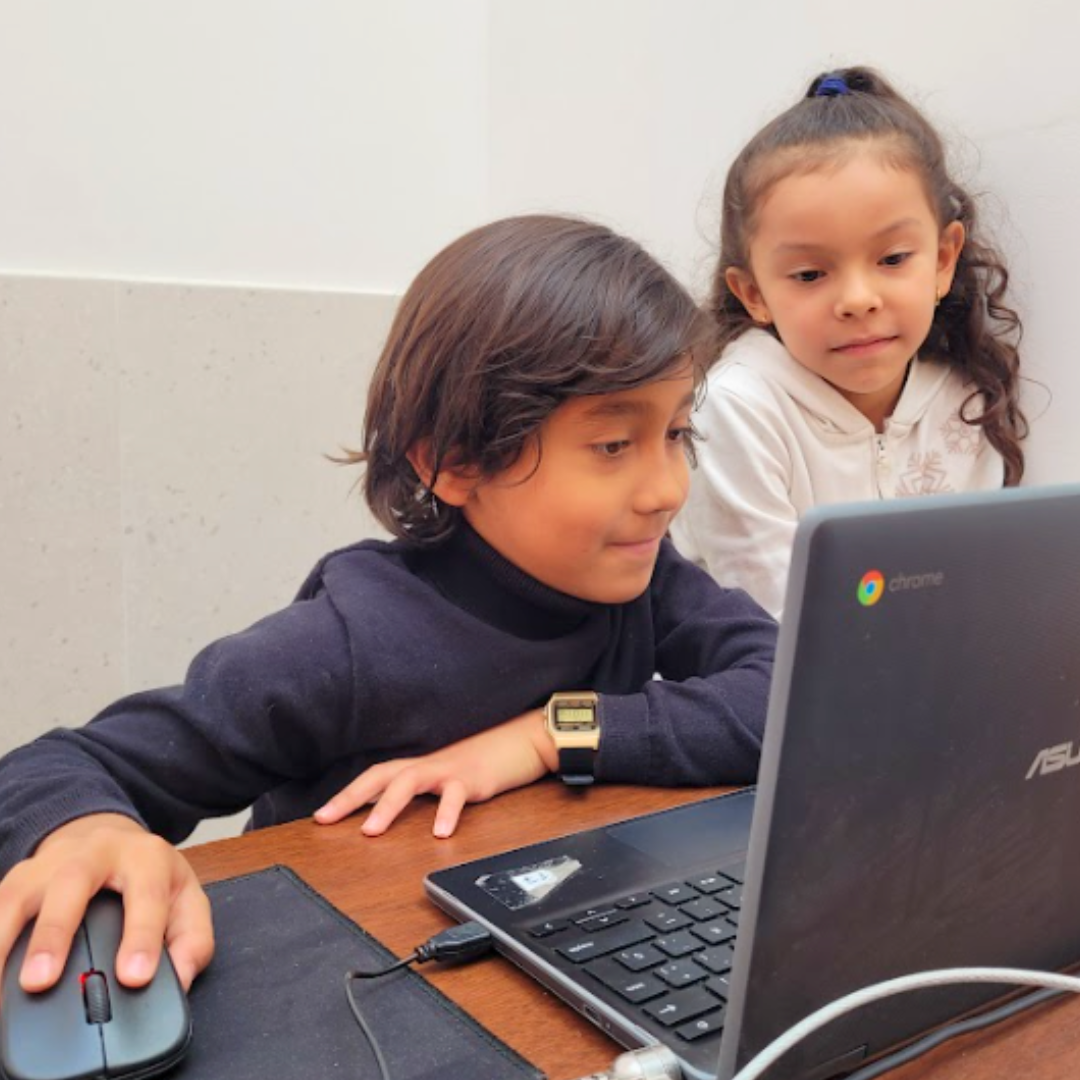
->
177;866;543;1080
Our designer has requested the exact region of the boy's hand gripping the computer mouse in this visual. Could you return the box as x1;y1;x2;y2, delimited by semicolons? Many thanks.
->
0;814;214;991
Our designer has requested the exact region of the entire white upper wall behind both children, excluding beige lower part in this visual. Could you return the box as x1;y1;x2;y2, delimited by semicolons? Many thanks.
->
0;0;1080;481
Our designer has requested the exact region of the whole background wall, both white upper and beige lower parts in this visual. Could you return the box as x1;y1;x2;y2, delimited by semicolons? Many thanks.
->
0;0;1080;842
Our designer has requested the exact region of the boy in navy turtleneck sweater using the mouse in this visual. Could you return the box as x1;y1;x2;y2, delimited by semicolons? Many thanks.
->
0;216;775;990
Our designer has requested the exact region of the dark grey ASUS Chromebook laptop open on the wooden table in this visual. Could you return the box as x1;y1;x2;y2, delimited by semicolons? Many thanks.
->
426;485;1080;1080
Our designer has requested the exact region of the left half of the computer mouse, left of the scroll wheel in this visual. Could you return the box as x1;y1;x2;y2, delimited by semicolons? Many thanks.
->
0;929;105;1080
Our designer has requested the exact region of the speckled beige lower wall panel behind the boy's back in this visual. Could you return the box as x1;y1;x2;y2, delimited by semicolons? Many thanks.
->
0;276;396;836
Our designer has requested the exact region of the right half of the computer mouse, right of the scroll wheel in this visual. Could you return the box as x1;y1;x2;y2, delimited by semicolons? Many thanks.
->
100;951;191;1080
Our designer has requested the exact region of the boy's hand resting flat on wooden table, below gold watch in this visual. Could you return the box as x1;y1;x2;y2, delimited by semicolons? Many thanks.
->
315;708;557;836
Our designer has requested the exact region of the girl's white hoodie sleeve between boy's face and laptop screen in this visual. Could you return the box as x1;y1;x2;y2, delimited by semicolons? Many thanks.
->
672;383;798;618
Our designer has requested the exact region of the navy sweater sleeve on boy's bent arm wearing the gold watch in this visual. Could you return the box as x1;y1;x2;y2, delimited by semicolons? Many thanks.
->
596;543;777;786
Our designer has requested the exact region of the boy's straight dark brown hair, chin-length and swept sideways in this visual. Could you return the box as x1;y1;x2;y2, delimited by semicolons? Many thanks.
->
342;215;715;543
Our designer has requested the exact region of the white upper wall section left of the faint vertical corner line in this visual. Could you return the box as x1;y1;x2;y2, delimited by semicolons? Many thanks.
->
0;0;488;292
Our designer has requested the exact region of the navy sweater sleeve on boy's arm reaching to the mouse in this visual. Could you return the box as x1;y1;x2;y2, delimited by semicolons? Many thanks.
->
0;595;353;876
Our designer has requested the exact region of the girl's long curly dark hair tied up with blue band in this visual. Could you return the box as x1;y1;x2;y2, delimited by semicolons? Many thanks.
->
711;67;1027;485
